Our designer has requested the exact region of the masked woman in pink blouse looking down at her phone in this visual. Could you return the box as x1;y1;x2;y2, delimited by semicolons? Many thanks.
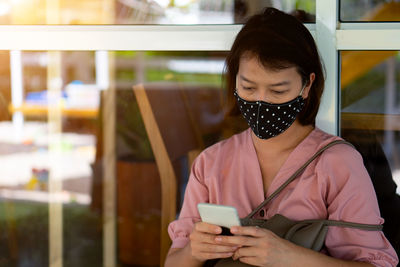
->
165;8;398;267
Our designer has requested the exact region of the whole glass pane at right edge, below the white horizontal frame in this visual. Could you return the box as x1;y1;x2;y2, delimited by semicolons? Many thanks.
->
341;51;400;193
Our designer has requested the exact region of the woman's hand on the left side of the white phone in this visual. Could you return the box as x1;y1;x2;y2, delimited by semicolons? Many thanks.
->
190;222;238;262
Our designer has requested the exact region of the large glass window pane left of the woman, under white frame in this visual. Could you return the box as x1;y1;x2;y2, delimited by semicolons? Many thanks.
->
0;51;246;266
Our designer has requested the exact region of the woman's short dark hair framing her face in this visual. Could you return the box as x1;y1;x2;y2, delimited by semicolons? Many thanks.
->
225;8;324;125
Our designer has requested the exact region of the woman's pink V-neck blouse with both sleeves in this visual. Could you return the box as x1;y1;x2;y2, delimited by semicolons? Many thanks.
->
168;128;398;266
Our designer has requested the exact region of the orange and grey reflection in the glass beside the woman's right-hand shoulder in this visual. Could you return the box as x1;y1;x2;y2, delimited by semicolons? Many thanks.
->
341;51;400;187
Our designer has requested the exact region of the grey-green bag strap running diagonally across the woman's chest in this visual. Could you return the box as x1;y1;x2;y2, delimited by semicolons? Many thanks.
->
246;140;354;219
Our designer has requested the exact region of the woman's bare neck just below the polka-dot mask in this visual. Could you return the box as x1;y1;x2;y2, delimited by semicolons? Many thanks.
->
251;120;314;154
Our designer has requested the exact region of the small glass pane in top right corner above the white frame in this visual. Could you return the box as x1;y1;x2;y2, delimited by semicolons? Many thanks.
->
340;0;400;21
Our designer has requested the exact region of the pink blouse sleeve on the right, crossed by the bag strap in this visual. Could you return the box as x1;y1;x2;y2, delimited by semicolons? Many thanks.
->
317;145;398;267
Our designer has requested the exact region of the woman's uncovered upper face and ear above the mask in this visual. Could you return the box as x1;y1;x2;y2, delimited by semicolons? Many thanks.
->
236;56;315;104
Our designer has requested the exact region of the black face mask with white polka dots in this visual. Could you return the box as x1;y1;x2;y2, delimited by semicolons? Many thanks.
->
234;90;304;139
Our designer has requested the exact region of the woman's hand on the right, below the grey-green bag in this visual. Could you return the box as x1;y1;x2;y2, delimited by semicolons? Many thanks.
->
215;226;297;266
